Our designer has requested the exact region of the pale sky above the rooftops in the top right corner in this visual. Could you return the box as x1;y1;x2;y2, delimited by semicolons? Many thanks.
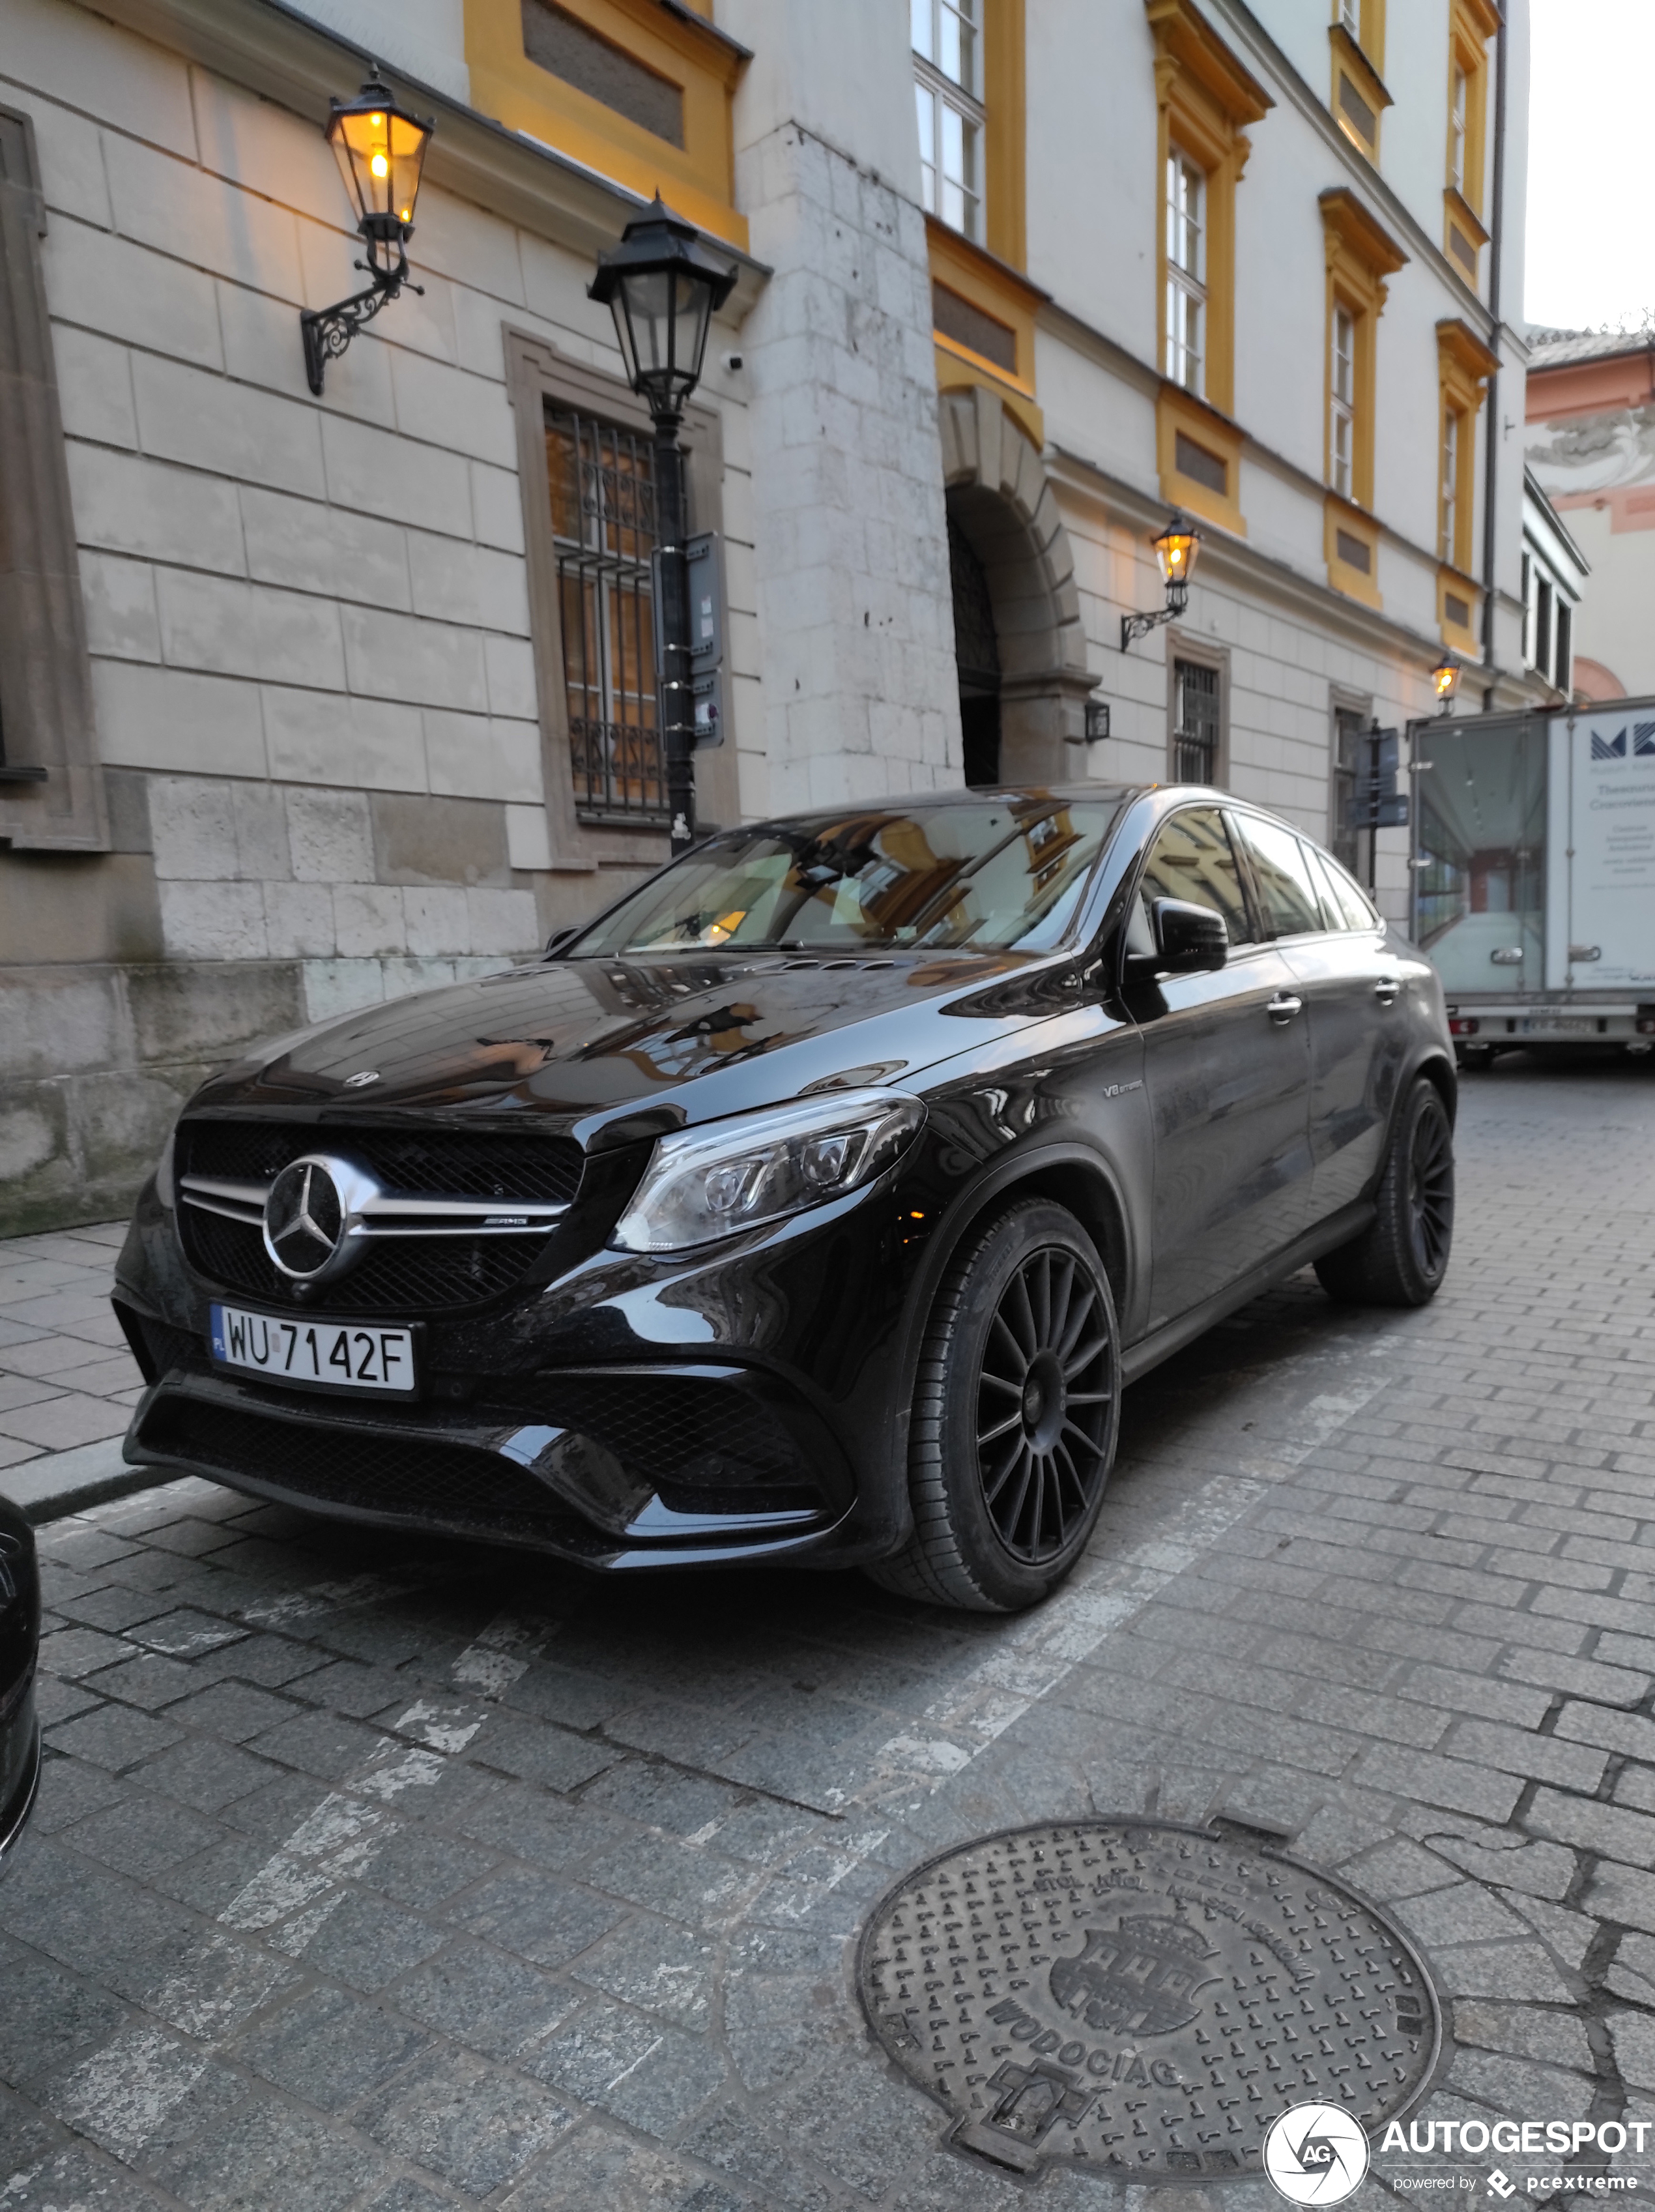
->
1506;0;1655;330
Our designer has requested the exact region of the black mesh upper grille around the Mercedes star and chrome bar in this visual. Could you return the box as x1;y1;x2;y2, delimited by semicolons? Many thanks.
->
177;1122;584;1314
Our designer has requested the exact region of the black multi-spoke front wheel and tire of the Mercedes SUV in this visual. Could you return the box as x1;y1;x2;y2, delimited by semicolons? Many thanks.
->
867;1199;1119;1612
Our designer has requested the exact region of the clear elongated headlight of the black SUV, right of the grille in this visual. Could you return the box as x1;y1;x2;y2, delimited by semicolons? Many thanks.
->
611;1090;925;1252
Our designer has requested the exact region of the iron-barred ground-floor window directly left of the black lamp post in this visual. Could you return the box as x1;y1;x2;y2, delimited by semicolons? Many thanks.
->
547;403;669;825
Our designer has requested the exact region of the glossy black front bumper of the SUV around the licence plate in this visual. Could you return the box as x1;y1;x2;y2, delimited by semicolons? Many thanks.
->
115;1159;929;1571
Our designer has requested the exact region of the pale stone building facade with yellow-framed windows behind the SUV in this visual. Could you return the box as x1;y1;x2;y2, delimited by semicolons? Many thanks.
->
0;0;1536;1230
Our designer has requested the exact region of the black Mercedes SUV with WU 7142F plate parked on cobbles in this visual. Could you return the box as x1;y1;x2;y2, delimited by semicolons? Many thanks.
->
115;785;1454;1610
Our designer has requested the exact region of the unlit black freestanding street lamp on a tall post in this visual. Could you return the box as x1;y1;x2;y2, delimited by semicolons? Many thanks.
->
586;192;737;854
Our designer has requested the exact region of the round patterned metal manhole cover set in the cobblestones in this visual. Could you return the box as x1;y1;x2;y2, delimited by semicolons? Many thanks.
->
859;1820;1441;2183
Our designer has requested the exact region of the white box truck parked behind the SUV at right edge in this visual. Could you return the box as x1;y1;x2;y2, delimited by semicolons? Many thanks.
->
1411;699;1655;1064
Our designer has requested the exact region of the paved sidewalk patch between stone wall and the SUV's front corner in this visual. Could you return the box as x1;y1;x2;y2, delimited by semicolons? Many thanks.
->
0;1221;144;1491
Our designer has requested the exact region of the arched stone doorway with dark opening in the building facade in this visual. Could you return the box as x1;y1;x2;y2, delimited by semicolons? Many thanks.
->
938;385;1095;783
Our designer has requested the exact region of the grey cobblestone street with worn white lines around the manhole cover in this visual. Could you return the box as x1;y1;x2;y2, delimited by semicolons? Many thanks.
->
0;1062;1655;2212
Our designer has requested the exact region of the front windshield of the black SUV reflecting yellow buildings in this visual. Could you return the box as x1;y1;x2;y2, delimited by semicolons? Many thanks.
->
569;794;1119;958
